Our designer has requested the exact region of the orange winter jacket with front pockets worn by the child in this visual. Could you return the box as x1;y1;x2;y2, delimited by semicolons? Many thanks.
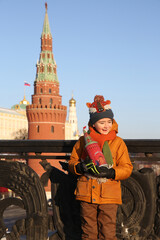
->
69;121;133;204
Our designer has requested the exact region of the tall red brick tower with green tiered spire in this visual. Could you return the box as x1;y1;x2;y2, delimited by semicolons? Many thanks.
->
27;3;67;140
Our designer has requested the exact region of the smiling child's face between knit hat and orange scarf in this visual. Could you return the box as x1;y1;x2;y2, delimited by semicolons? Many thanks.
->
93;118;112;134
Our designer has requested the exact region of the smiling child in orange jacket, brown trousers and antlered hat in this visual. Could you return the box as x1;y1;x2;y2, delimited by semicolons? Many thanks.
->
69;95;133;240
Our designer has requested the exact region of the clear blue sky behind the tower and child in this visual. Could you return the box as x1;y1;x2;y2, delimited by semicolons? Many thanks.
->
0;0;160;139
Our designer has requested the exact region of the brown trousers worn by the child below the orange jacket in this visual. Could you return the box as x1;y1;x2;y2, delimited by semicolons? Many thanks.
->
81;202;118;240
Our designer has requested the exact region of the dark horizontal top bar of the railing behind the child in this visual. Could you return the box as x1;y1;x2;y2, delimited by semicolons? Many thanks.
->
0;139;160;153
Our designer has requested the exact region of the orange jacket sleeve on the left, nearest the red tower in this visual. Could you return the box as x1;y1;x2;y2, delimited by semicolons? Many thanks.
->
68;137;84;175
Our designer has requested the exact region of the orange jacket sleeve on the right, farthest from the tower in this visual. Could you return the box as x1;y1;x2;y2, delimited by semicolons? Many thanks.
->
113;139;133;180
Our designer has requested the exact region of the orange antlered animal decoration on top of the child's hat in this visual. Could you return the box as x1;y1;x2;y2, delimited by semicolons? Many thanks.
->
86;95;111;113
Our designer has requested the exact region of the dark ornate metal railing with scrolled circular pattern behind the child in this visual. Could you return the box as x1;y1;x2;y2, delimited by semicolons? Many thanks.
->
0;139;160;240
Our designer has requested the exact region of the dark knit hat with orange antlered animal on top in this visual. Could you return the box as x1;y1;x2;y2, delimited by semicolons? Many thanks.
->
86;95;114;125
